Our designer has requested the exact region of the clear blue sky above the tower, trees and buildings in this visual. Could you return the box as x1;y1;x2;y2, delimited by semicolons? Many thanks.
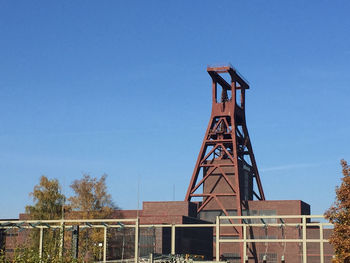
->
0;0;350;218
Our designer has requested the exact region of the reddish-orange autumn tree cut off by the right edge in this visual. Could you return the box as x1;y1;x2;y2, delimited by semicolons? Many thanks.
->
325;160;350;263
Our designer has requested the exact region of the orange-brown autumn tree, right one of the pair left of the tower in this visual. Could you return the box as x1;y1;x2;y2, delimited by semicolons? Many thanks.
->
68;174;117;259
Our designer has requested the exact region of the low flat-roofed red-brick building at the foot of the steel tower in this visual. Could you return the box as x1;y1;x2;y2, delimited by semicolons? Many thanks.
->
117;200;333;263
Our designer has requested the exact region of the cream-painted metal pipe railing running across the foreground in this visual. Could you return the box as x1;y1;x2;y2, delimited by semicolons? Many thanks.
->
0;215;333;263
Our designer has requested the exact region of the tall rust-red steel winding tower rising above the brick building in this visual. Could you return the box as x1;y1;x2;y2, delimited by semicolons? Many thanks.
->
185;66;265;260
